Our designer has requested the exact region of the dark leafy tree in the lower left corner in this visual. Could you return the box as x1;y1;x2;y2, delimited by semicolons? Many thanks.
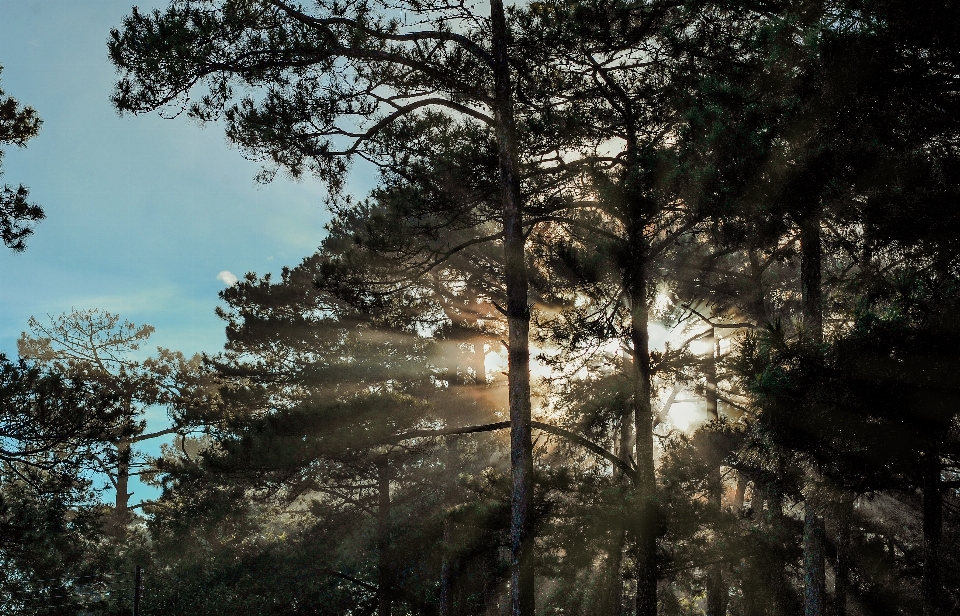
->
0;355;116;613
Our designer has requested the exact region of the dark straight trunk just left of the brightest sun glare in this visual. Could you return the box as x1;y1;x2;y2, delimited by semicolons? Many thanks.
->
625;238;657;616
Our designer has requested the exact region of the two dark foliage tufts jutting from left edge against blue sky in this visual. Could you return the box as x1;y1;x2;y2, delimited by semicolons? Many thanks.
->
0;66;44;252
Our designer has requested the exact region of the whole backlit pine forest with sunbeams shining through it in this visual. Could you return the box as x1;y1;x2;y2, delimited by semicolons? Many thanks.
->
0;0;960;616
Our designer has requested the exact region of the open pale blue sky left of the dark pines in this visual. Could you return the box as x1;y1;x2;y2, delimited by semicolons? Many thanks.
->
0;0;370;501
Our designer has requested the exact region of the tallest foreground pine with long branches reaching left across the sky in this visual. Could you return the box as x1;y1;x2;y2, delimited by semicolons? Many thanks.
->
110;0;534;614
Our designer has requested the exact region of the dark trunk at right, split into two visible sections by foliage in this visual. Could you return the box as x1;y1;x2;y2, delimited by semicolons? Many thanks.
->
799;204;827;616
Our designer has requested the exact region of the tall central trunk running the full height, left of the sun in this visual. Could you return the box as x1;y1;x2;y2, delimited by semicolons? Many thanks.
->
490;0;534;616
